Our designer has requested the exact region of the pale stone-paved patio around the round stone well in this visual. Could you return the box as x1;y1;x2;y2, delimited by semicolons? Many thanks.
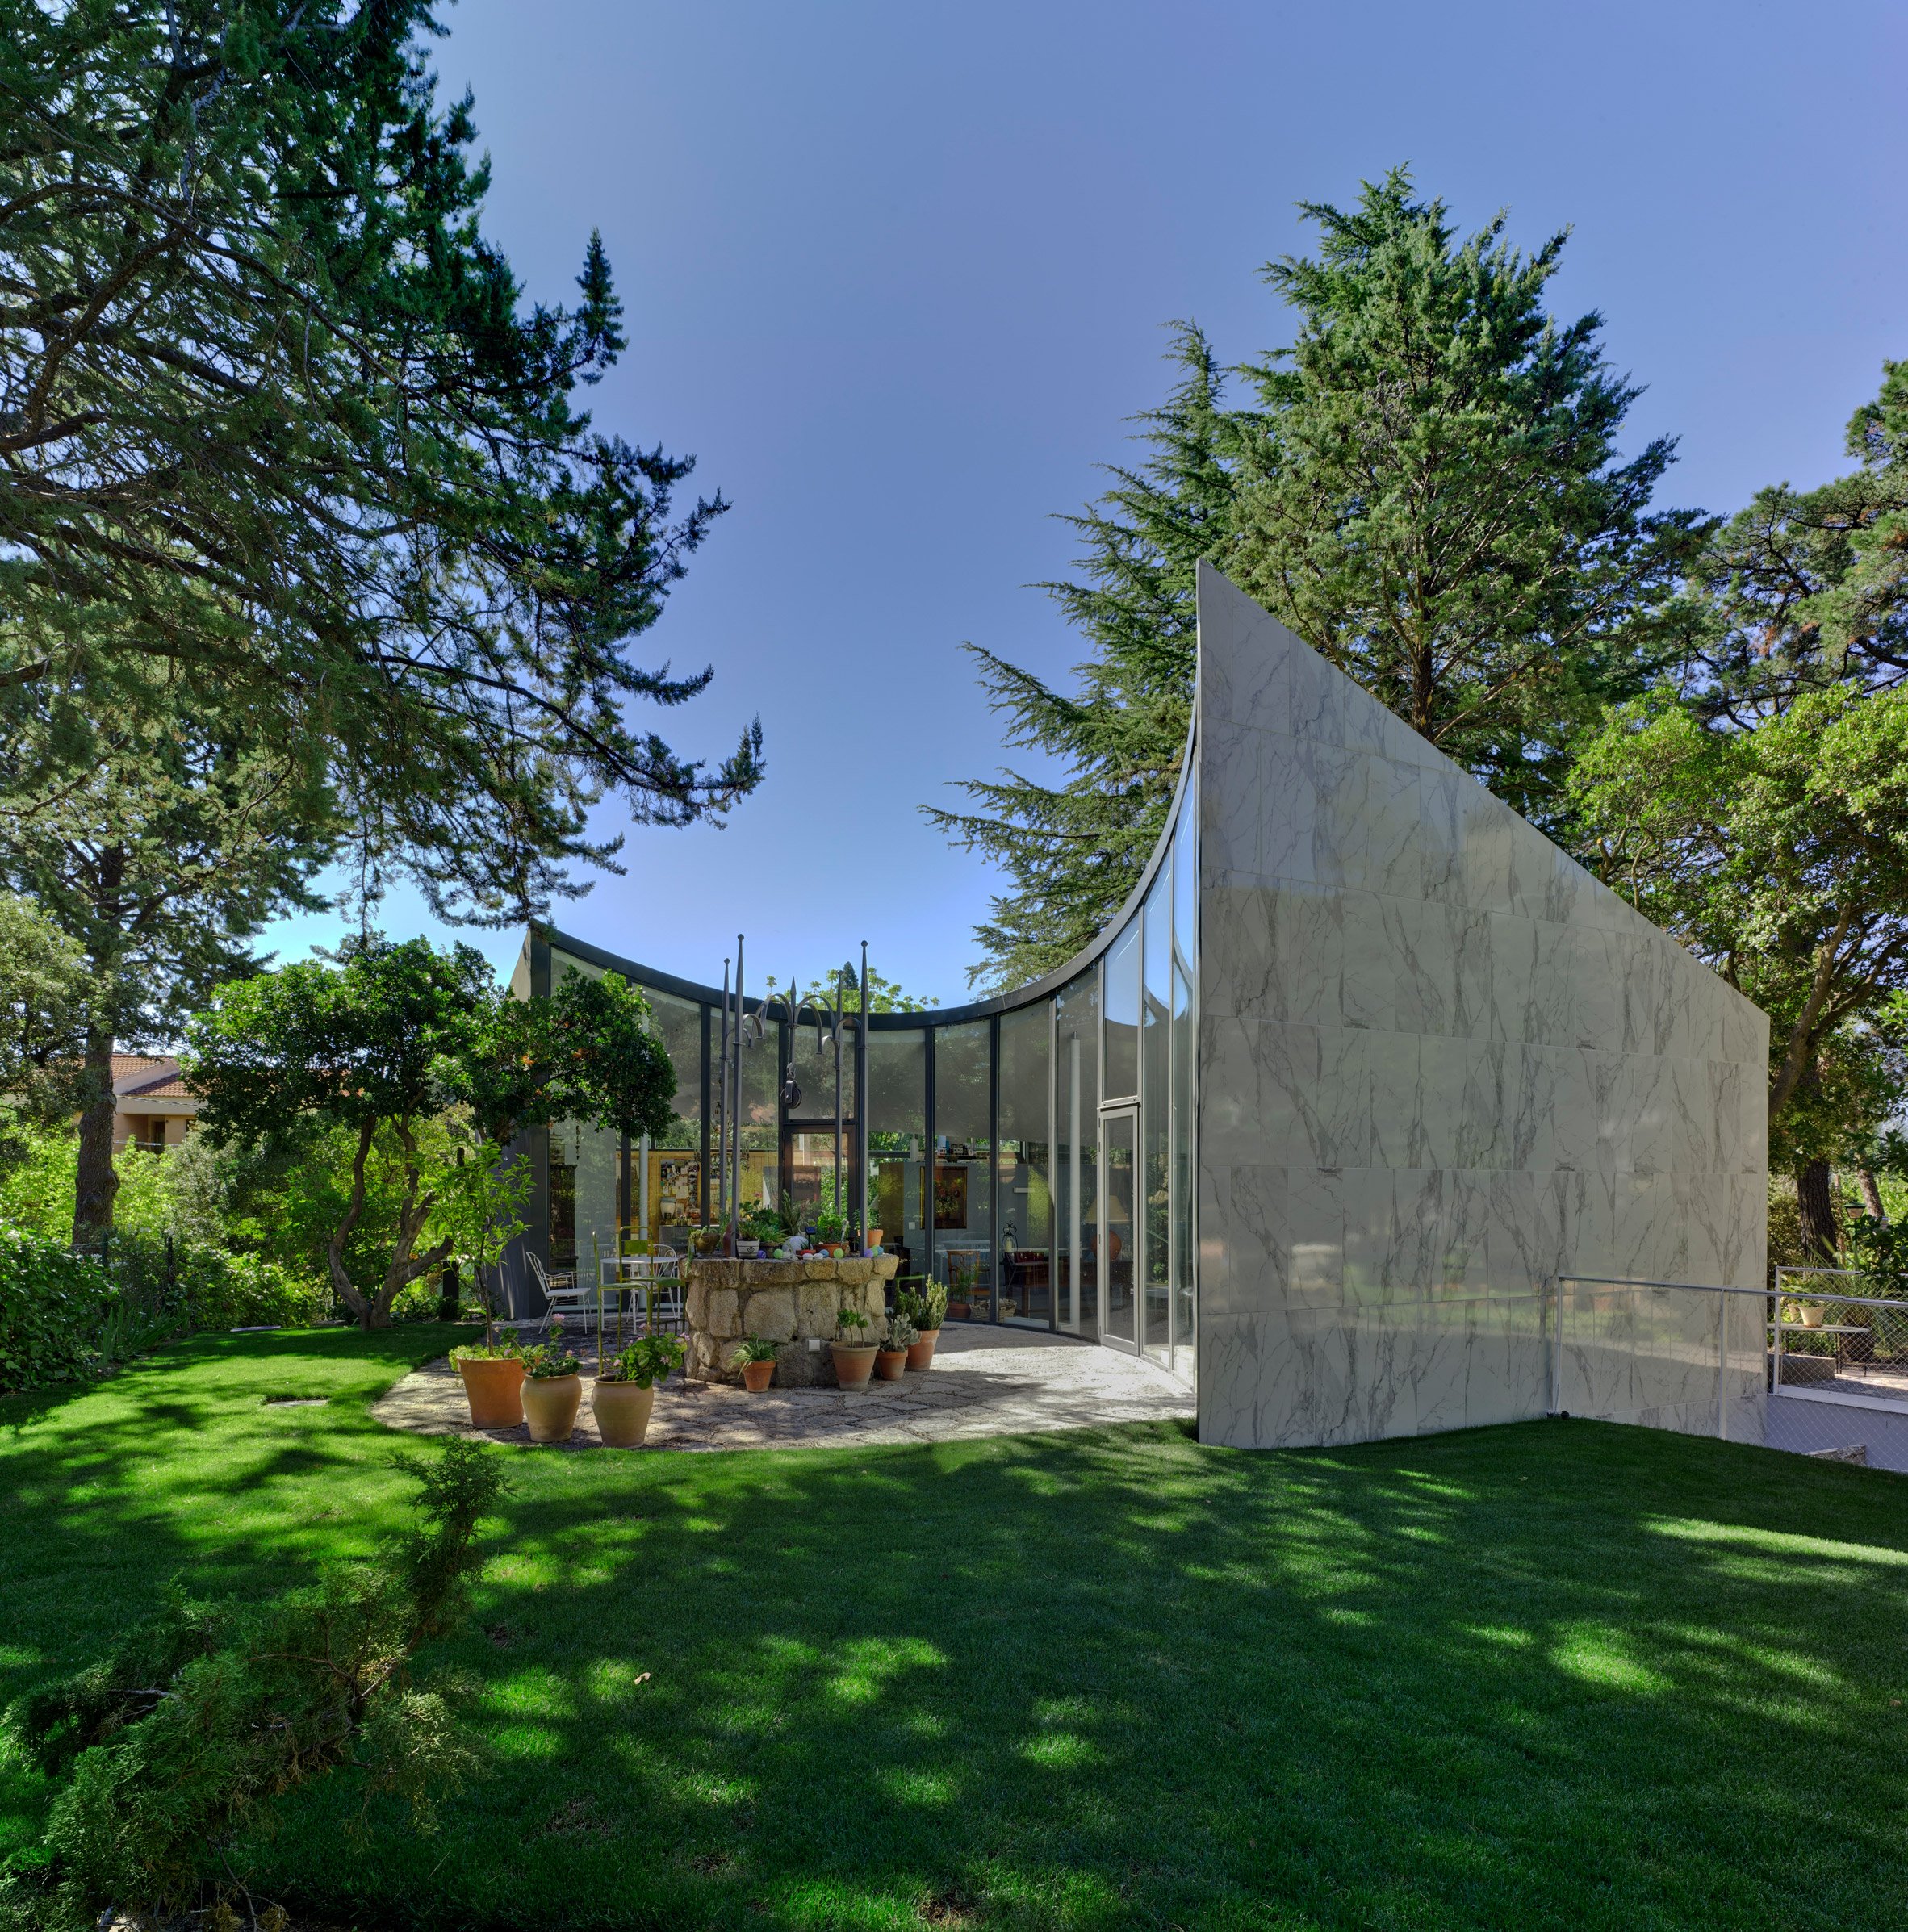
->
371;1325;1193;1449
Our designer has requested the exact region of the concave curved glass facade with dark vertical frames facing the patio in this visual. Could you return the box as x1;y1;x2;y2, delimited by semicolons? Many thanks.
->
507;730;1199;1382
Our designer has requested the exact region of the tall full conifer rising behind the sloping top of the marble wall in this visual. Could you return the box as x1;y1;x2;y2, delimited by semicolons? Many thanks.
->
1233;168;1711;825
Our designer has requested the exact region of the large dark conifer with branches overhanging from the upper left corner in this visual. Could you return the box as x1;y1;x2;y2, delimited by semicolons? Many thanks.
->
0;0;759;922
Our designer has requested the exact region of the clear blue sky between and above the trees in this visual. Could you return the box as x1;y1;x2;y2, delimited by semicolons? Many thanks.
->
263;0;1908;1002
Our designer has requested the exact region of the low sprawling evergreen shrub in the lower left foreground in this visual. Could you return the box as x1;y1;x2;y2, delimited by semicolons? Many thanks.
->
0;1440;504;1926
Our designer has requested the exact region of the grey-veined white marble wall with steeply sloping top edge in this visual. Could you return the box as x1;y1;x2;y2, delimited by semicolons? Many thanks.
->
1199;566;1767;1445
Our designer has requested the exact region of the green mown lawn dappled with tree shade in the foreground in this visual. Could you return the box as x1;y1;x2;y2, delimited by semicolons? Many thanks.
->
0;1328;1908;1932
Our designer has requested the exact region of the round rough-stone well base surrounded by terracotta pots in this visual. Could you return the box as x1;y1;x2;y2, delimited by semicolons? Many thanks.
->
684;1254;901;1389
